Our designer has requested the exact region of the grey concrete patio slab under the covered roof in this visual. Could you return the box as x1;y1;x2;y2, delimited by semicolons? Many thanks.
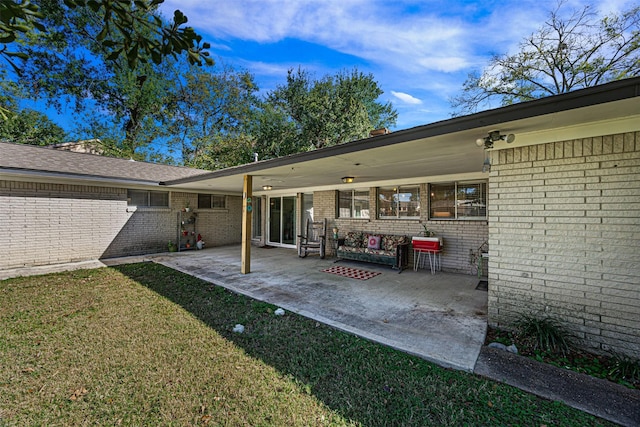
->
145;246;487;372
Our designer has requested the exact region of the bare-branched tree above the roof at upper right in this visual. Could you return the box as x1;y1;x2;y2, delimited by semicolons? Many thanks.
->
451;1;640;114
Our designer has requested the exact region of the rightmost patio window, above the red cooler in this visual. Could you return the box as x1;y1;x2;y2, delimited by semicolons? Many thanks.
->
429;182;487;219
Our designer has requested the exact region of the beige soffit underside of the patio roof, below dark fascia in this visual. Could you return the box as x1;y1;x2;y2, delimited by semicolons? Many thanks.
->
168;97;640;194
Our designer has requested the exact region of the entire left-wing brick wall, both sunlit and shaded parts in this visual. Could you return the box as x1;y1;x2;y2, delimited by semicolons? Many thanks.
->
0;181;242;269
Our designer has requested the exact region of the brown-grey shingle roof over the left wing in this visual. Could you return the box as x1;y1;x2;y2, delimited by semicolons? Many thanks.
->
0;142;210;183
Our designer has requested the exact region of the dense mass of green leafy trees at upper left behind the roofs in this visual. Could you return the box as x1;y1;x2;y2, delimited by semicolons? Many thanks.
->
0;0;397;169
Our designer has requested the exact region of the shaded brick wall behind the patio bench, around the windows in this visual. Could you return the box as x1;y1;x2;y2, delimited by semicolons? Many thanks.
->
313;188;488;274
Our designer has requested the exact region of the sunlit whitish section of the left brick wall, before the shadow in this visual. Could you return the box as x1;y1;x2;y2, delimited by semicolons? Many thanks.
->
0;181;129;268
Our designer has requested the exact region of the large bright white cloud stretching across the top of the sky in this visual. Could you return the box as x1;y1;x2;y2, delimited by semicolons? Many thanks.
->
161;0;633;74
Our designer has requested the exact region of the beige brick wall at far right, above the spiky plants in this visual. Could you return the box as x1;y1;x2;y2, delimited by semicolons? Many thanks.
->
489;133;640;357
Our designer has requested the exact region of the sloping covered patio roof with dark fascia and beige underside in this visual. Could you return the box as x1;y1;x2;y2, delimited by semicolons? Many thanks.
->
161;78;640;194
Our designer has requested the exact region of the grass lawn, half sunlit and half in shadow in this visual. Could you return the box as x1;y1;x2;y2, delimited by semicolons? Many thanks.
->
0;264;611;426
